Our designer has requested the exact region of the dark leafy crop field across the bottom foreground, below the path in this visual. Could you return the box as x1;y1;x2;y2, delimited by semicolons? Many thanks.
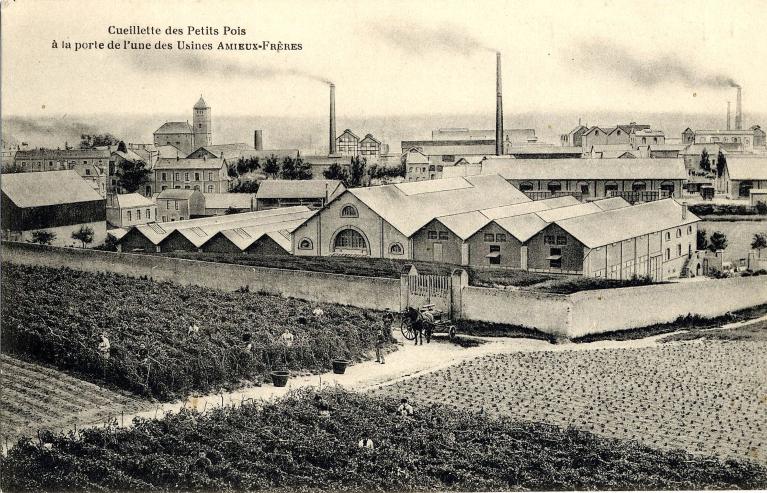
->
0;389;767;491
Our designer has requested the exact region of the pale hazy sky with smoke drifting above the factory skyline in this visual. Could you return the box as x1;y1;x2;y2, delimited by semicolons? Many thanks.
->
2;0;767;117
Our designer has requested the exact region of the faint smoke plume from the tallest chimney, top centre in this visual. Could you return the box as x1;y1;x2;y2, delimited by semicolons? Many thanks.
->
366;20;496;56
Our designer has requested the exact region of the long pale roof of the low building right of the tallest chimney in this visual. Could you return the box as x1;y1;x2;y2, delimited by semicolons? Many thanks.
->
482;156;687;180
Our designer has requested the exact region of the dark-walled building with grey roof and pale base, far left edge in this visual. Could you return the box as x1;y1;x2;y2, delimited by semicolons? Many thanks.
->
0;170;106;246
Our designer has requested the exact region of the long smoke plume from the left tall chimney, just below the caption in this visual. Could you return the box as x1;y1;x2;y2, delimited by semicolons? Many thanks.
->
130;53;331;84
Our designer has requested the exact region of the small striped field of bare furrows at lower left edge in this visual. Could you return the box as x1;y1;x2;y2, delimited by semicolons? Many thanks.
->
0;354;149;447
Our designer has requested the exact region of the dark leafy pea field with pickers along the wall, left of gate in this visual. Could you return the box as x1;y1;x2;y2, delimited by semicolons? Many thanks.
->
1;263;381;400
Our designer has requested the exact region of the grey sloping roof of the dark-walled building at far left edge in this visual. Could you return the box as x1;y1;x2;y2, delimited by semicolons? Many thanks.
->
0;170;104;207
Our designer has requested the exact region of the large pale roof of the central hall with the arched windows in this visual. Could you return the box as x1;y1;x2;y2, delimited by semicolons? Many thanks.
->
347;175;530;237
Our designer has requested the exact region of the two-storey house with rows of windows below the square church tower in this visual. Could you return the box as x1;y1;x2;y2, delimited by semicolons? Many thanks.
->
153;156;230;193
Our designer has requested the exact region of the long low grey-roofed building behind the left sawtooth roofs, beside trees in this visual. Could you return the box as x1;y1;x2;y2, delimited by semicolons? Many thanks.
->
255;180;346;211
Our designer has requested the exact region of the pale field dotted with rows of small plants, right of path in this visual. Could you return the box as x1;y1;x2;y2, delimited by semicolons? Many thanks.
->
374;340;767;463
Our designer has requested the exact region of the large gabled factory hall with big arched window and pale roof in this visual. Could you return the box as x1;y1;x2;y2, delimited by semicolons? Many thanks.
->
293;175;530;261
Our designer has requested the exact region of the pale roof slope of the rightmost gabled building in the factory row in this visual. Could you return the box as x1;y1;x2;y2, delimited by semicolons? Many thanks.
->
557;199;700;248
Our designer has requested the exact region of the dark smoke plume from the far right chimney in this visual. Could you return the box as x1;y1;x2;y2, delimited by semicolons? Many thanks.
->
570;40;738;88
